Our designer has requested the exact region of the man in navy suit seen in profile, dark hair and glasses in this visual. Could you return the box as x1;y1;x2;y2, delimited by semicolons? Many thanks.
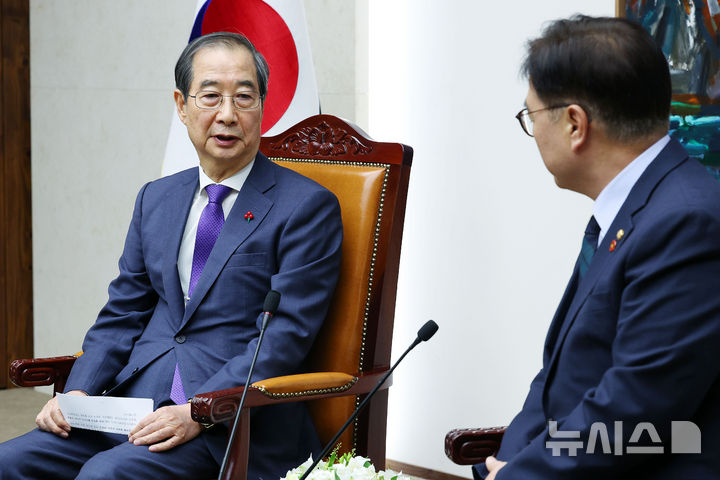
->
480;16;720;480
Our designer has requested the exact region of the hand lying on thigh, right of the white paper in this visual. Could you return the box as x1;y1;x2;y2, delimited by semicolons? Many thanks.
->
128;403;202;452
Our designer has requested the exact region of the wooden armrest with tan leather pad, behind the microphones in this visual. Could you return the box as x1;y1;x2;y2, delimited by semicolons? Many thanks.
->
191;369;392;423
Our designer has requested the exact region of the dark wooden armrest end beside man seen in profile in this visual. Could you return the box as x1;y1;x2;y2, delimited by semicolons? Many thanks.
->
445;427;505;465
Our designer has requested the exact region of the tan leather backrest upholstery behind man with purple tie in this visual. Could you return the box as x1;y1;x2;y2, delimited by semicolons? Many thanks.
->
273;158;388;451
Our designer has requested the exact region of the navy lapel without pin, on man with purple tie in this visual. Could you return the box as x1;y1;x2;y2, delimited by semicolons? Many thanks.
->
158;169;199;319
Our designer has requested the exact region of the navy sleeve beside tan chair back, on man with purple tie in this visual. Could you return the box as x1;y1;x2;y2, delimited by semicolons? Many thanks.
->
196;190;342;393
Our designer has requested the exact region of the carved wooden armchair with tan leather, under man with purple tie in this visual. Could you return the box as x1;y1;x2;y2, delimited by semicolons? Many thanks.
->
10;115;412;479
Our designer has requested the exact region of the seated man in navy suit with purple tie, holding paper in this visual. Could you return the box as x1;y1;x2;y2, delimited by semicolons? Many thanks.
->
0;33;342;480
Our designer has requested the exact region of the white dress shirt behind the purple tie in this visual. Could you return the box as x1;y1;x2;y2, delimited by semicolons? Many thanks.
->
177;160;255;303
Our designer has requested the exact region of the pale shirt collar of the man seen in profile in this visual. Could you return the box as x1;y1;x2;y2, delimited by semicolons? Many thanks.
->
593;135;670;245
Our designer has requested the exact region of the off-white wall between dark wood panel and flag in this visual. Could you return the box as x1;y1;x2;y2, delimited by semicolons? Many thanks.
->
30;0;195;356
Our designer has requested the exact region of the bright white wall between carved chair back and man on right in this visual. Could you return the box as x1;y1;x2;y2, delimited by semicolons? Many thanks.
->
369;0;615;477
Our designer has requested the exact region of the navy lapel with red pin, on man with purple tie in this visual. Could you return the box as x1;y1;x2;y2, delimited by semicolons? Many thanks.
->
180;153;275;329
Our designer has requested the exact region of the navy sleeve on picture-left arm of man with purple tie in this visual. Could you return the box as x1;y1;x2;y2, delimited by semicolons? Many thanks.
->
65;184;158;395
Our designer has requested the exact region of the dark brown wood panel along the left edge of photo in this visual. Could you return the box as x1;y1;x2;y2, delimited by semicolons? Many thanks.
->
0;0;33;388
